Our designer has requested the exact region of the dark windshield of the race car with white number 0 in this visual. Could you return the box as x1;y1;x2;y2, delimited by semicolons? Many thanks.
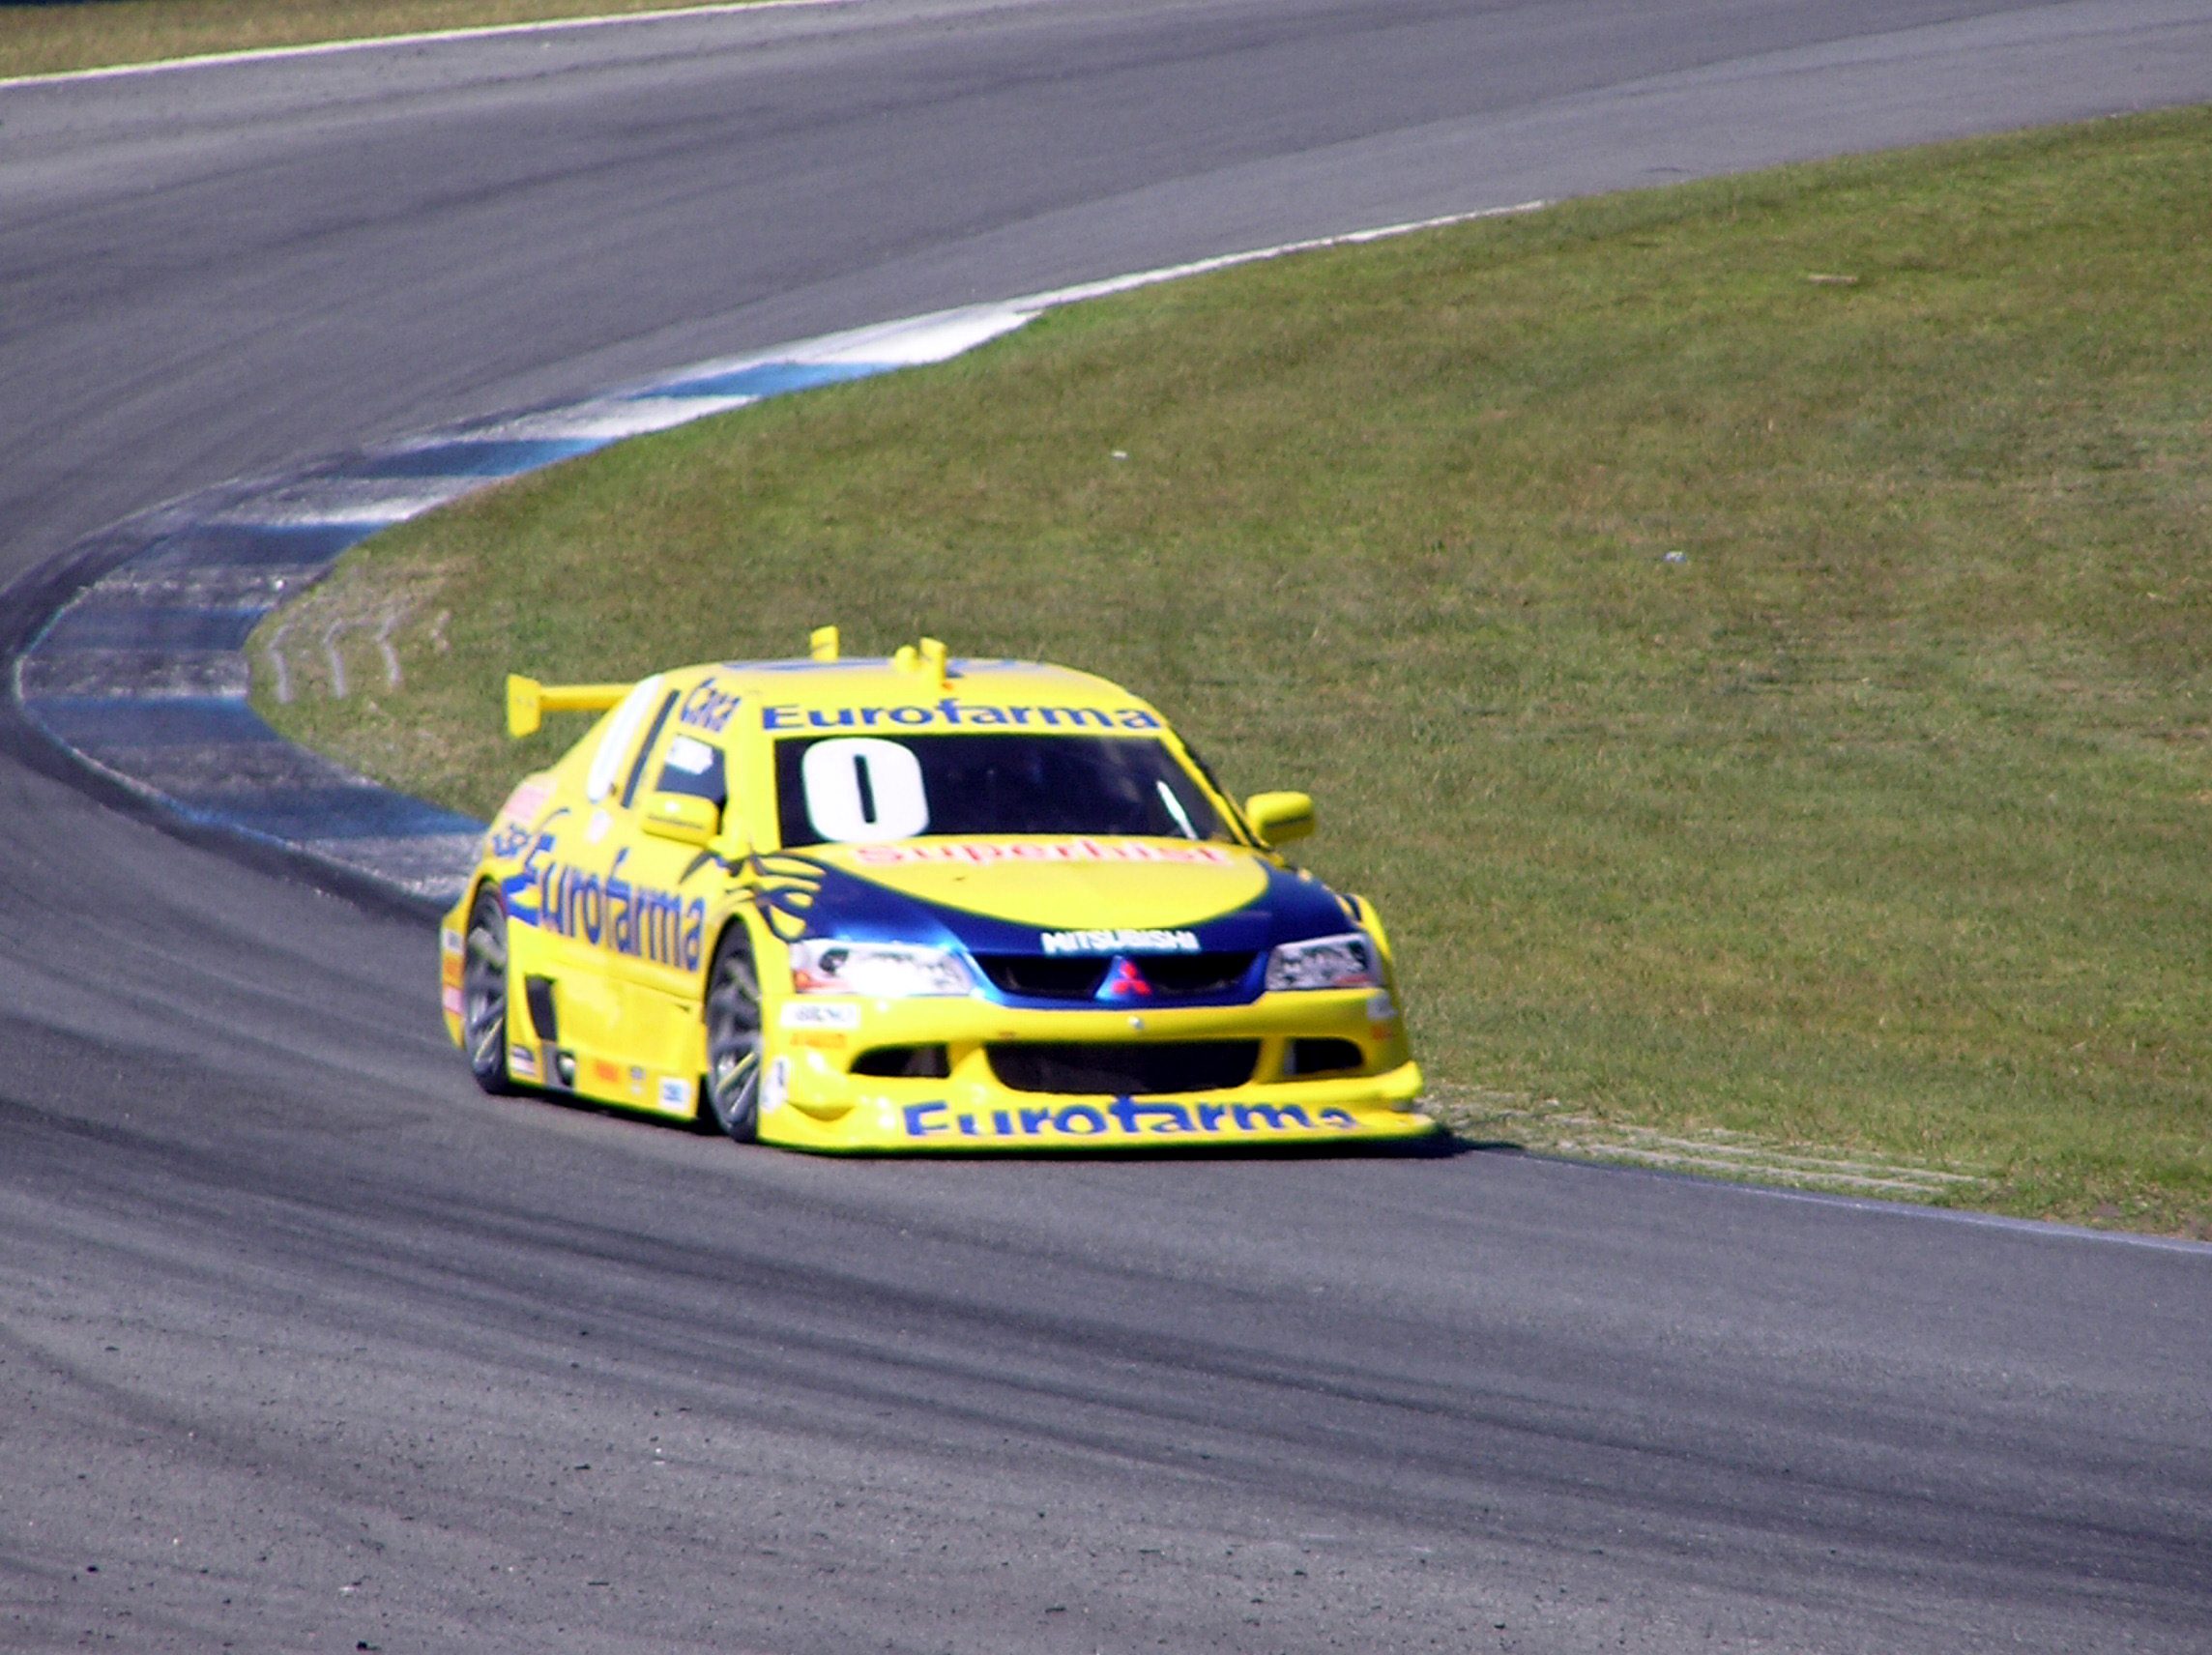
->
776;735;1230;848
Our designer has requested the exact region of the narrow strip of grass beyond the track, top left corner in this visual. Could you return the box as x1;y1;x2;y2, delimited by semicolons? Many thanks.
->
0;0;747;79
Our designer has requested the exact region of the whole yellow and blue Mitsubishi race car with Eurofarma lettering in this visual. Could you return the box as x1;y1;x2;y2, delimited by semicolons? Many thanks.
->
440;626;1436;1150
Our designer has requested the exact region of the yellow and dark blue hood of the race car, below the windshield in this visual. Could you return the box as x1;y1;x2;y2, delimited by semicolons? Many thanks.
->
794;836;1352;953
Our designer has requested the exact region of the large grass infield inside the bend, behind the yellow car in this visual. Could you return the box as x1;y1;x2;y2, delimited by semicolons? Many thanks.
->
263;110;2212;1234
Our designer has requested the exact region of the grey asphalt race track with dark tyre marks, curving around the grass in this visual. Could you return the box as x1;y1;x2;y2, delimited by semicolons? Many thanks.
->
0;0;2212;1655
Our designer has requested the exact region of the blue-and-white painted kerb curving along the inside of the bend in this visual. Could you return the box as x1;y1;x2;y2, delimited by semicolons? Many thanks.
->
14;201;1542;901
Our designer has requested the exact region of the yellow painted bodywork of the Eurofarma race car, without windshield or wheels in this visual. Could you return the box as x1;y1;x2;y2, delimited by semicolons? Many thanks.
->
440;635;1436;1152
